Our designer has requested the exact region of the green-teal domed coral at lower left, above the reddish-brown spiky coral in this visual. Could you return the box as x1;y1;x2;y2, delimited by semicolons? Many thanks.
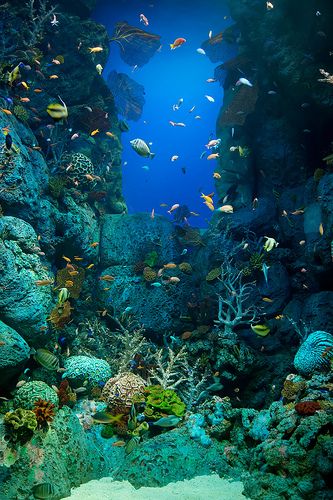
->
13;380;59;410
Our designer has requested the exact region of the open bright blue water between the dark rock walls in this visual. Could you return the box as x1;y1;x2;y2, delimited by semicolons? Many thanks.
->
93;0;234;227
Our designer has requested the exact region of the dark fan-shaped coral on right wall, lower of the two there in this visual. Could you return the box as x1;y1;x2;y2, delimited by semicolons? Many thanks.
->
218;85;258;127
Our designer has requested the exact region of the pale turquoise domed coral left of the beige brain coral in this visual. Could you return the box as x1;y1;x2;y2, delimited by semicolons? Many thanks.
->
62;356;111;390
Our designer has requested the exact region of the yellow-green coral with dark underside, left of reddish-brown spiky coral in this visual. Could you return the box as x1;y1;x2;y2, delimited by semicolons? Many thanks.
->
4;408;37;443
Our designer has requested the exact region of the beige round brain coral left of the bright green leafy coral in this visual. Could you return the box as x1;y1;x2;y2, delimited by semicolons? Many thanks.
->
102;373;147;411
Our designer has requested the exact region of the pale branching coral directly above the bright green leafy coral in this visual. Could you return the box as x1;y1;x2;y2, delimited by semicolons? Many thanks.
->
150;346;188;389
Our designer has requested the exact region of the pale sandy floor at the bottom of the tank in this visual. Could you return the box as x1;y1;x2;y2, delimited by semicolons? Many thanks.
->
65;475;246;500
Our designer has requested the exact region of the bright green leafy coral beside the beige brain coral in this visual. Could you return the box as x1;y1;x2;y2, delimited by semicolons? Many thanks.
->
144;385;186;420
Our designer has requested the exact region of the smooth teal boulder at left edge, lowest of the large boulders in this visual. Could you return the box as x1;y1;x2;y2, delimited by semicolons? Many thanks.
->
0;321;30;388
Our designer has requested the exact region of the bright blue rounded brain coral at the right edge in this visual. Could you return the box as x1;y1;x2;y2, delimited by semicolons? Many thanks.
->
294;330;333;375
